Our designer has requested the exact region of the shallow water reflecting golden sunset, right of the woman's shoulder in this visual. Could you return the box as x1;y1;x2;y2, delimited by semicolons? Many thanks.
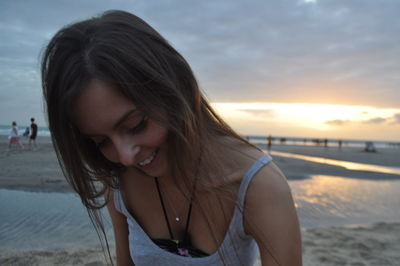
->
289;175;400;227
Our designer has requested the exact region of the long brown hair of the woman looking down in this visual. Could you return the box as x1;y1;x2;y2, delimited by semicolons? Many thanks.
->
42;11;260;264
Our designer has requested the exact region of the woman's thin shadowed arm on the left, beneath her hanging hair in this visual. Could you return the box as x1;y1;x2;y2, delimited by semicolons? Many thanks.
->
107;190;134;266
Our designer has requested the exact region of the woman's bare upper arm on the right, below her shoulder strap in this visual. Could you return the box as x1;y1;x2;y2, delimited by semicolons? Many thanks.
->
244;163;302;266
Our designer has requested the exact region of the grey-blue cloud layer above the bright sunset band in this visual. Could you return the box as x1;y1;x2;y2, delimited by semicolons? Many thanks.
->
0;0;400;123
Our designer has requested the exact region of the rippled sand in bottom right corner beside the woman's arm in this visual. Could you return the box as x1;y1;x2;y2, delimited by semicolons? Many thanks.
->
302;223;400;266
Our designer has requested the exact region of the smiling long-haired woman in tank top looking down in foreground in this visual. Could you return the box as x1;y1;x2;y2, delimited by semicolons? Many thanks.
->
42;11;301;266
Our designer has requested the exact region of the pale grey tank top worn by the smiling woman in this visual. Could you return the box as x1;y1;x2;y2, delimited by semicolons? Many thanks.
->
114;155;272;266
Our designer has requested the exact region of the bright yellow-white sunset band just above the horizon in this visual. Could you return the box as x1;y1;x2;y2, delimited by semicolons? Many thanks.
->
213;103;400;141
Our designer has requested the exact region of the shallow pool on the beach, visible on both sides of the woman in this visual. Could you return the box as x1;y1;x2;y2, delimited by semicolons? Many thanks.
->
0;176;400;250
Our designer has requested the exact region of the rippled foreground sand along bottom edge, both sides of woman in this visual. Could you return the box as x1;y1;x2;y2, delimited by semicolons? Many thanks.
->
0;223;400;266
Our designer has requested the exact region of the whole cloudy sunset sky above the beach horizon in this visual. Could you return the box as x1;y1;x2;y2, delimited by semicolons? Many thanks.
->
0;0;400;141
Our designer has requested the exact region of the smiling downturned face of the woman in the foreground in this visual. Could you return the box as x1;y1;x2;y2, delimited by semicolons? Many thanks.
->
73;79;168;177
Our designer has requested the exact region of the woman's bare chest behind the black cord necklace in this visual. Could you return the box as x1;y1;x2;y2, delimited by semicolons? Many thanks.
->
122;178;236;254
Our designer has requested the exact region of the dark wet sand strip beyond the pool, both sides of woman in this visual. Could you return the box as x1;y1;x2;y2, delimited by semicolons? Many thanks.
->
0;136;400;193
